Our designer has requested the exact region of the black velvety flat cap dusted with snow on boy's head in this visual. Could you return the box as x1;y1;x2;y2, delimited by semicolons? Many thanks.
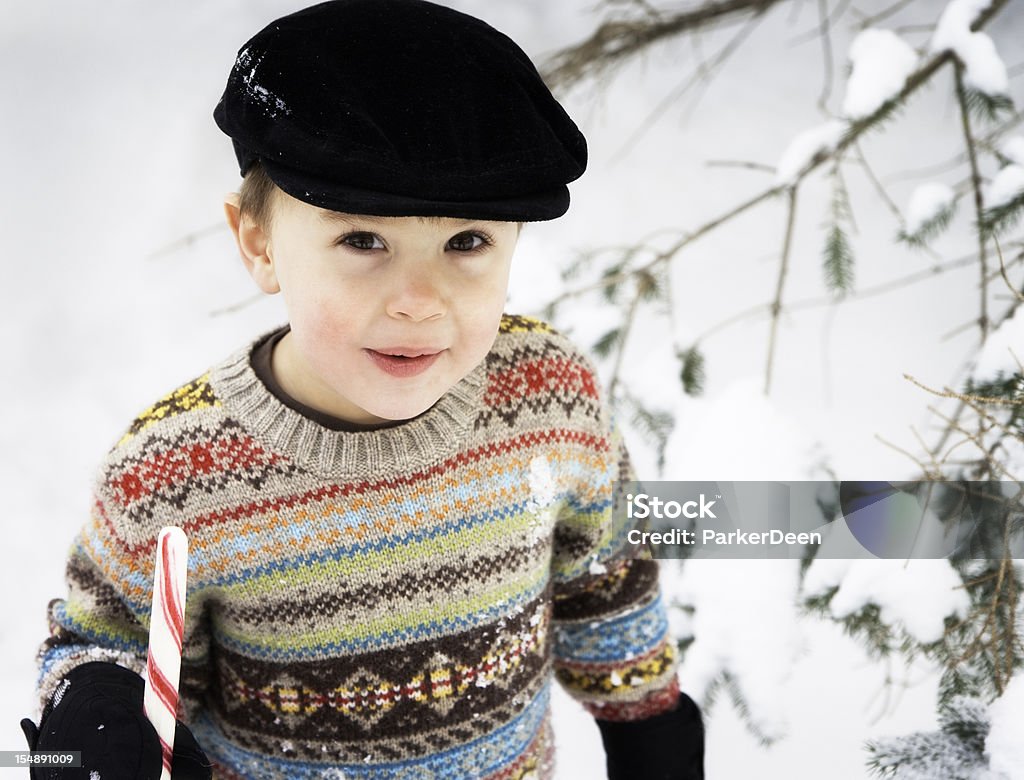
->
213;0;587;221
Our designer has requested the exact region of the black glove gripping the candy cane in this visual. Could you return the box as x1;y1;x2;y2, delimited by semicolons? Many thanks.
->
22;661;211;780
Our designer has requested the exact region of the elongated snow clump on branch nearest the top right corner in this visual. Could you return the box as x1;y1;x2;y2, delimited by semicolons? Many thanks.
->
929;0;1010;95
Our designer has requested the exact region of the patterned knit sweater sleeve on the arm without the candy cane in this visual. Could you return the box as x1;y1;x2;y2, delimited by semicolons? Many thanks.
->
553;386;679;721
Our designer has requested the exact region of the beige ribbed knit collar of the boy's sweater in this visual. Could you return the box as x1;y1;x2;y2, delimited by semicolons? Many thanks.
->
210;335;484;479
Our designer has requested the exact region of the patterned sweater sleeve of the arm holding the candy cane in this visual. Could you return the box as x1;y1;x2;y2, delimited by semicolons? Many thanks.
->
37;484;209;722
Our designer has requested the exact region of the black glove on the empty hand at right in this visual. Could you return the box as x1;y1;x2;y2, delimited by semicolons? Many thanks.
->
597;693;703;780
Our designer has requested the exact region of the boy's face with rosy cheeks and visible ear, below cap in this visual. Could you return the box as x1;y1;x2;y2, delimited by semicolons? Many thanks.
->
228;191;519;425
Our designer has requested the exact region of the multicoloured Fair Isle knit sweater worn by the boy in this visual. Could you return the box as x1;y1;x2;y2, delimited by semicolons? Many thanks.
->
40;316;678;780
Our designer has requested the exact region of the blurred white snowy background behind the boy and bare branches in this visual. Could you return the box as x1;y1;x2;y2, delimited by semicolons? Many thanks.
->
6;0;1024;780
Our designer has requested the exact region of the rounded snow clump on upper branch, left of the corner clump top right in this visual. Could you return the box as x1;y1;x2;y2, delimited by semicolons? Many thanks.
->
843;29;918;119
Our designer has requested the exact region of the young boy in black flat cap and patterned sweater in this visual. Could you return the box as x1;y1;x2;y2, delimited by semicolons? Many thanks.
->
23;0;702;780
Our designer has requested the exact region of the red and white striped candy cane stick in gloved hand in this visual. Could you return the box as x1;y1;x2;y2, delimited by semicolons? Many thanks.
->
142;526;188;780
